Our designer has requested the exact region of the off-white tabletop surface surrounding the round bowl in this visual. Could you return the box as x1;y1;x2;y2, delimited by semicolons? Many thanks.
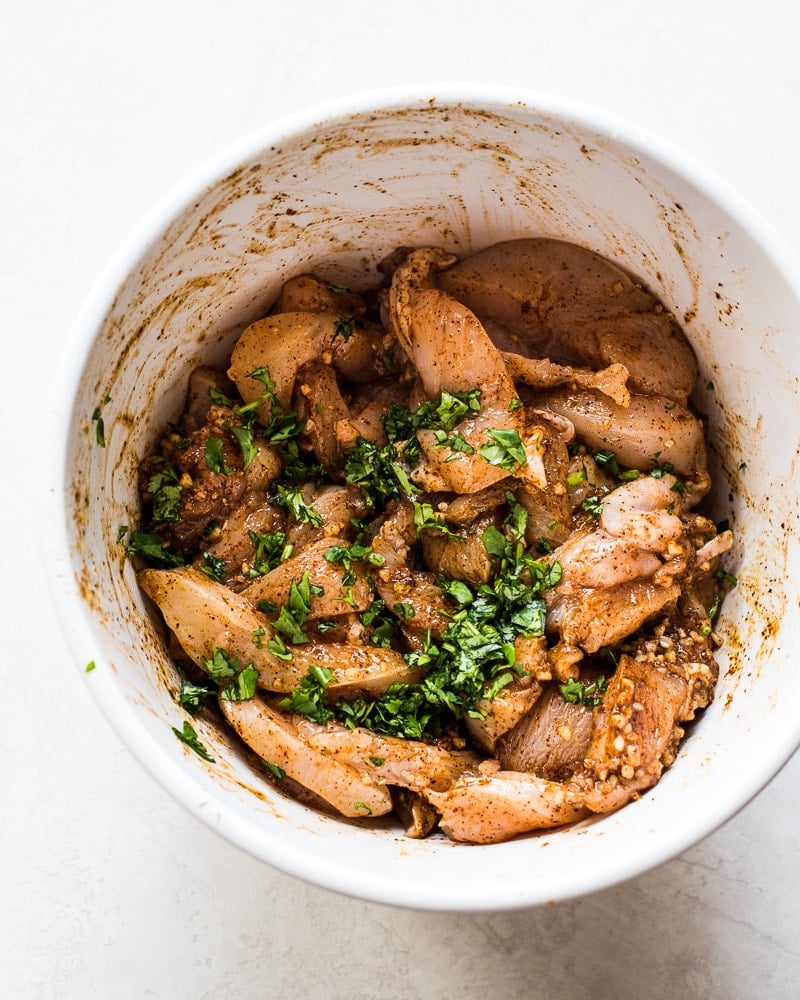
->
0;0;800;1000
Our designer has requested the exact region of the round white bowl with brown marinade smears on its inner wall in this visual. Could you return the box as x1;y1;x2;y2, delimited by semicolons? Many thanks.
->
47;86;800;910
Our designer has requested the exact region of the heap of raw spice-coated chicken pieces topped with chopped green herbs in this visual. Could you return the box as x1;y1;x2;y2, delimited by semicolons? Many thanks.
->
126;239;735;843
